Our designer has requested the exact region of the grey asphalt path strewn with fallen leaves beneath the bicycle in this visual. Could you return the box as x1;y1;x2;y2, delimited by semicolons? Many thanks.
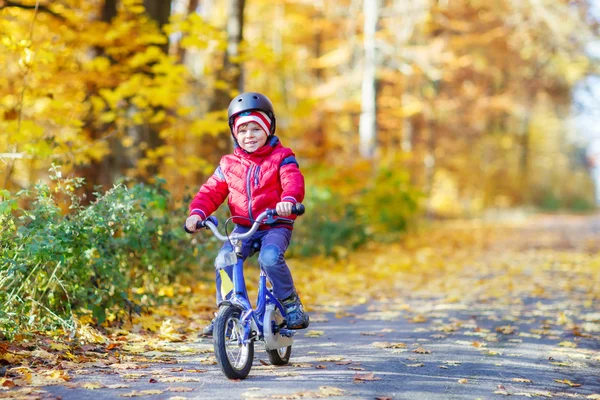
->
35;217;600;400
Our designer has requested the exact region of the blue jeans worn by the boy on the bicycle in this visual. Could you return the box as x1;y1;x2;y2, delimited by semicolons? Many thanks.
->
215;226;295;305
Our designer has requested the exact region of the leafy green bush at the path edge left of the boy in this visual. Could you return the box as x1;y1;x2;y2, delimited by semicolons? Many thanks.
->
0;166;215;336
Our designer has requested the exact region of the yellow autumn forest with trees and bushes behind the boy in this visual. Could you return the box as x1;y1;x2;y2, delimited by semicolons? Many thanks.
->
0;0;598;338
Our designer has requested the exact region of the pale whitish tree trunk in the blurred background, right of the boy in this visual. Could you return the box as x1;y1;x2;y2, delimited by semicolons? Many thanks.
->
359;0;379;159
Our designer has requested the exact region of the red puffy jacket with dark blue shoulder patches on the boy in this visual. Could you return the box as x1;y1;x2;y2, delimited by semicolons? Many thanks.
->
190;136;304;229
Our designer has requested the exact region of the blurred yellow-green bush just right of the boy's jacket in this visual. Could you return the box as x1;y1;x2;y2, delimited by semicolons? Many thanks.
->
289;164;422;256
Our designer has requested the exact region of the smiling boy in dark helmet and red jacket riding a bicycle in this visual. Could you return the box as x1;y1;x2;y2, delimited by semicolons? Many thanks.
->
185;92;309;336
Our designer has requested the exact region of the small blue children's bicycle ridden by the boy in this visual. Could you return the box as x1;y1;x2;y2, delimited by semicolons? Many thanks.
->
186;204;304;379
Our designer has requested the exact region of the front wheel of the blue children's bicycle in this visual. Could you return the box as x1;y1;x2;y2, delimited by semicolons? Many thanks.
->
213;305;254;379
